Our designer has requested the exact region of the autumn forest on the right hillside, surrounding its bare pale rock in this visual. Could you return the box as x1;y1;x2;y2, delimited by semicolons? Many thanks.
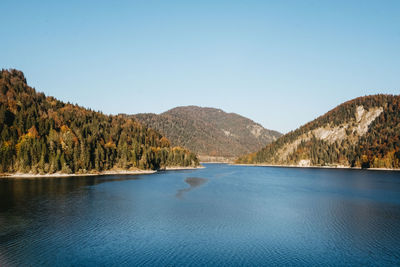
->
237;94;400;168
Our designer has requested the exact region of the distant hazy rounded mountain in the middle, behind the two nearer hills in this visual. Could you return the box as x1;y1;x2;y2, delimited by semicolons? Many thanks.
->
133;106;281;161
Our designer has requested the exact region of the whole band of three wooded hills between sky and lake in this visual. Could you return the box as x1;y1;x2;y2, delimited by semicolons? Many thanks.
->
0;69;400;175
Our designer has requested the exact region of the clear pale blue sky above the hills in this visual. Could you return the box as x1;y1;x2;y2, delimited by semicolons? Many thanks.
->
0;0;400;132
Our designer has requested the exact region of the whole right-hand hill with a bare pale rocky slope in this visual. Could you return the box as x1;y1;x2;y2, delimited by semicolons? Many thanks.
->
237;95;400;168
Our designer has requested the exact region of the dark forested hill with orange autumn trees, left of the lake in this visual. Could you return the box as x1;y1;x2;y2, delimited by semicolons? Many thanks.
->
0;70;198;173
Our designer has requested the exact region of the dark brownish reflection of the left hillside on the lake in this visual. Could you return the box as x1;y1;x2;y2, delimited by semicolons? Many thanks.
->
0;175;142;251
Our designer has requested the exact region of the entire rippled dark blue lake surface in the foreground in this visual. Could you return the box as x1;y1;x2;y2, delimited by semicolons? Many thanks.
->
0;164;400;266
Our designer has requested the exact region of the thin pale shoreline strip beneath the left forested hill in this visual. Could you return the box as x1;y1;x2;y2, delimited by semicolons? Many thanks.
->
0;165;205;179
